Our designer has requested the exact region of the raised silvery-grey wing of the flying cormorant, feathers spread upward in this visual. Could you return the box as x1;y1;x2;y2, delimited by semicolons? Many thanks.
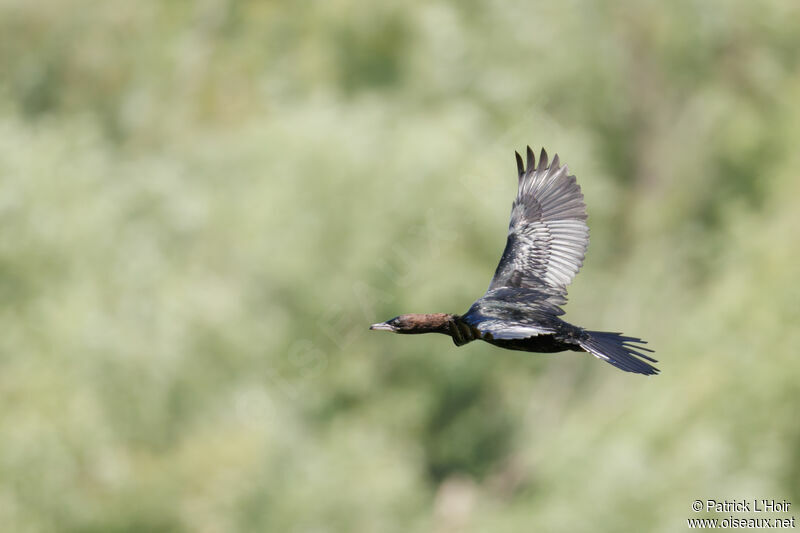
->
487;146;589;304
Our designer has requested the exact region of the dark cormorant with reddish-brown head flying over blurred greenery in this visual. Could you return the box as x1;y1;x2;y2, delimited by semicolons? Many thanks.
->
370;146;659;375
